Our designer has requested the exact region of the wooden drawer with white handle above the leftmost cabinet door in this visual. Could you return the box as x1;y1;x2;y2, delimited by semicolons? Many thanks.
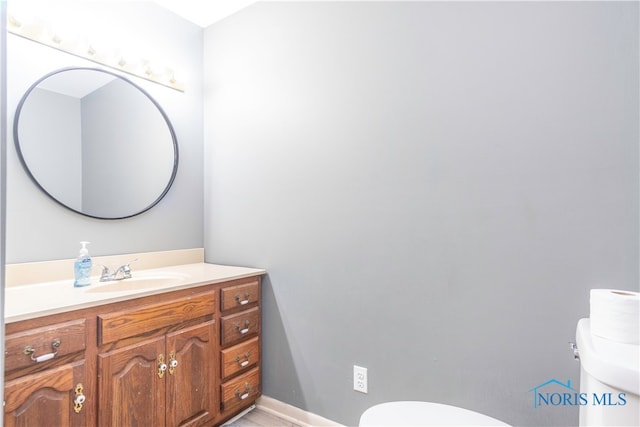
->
4;319;85;372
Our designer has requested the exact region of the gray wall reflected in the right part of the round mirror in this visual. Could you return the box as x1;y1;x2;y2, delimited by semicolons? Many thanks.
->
82;80;174;217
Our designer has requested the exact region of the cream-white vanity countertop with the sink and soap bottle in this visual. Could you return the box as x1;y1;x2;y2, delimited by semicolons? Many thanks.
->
4;262;266;323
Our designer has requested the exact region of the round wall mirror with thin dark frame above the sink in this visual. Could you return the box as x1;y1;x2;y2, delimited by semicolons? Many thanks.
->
13;68;178;219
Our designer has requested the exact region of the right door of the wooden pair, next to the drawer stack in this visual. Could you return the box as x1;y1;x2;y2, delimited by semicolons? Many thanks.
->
167;320;218;426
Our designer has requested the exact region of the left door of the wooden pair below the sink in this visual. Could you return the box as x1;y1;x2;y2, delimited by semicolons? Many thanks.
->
98;337;167;427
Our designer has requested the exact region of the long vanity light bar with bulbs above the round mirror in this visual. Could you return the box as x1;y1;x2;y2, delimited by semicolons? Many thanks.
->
7;10;184;92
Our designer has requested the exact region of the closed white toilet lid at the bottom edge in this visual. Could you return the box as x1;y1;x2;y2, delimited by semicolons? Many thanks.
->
360;402;508;427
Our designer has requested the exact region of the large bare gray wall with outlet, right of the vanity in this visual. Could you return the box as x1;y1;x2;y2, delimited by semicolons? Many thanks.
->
205;2;639;425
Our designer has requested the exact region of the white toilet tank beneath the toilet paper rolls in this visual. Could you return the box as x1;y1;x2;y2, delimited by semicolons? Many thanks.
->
576;319;640;427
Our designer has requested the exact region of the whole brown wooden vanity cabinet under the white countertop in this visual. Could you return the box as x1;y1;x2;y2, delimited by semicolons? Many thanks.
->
5;276;260;427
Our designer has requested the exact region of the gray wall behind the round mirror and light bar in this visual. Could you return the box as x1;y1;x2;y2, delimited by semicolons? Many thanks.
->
6;2;204;263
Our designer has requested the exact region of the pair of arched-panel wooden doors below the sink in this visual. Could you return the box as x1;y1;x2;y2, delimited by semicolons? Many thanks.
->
98;321;217;426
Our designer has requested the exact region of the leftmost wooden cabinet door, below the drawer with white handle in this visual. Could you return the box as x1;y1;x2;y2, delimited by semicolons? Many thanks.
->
4;361;90;427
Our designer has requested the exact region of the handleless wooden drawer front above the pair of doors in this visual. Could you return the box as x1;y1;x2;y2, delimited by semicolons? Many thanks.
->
98;292;215;345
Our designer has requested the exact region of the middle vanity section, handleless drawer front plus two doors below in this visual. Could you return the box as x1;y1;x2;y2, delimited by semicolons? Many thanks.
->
98;291;218;426
